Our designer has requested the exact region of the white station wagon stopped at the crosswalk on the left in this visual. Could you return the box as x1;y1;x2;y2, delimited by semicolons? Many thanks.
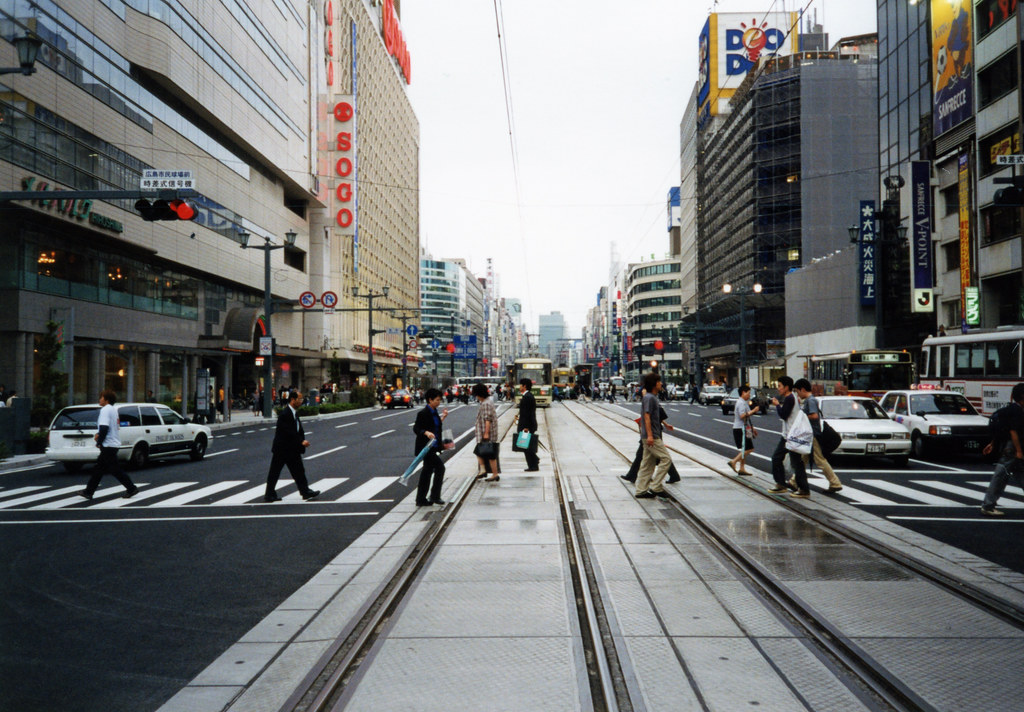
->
46;403;210;472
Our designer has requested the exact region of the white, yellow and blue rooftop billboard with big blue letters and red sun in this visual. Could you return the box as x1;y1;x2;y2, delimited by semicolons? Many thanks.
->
697;12;800;116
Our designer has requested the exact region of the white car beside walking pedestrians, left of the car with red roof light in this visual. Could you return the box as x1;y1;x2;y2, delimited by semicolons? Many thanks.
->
818;395;910;467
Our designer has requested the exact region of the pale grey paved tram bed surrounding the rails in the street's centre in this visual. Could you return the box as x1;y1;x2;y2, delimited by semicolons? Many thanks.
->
155;404;1024;712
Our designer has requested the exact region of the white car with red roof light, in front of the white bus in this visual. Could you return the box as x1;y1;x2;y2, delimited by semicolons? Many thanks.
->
880;390;989;458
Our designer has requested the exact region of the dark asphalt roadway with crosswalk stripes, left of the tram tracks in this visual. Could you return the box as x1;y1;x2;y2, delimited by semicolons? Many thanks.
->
0;404;493;712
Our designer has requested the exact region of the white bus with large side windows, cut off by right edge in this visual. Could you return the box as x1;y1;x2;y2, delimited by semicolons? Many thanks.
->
918;327;1024;415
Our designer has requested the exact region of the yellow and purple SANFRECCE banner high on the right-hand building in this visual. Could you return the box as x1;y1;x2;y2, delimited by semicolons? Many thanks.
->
932;0;974;136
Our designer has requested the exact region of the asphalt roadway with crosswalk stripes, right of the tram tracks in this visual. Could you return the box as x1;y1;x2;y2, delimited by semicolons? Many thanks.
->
600;401;1024;573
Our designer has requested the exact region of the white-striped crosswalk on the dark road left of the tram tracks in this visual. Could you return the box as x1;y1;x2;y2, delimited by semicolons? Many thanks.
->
0;476;398;511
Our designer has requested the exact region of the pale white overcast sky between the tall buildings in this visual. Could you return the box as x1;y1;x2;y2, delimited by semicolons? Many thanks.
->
401;0;877;337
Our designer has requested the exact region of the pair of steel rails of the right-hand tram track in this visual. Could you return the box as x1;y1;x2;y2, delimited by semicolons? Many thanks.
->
566;405;1024;710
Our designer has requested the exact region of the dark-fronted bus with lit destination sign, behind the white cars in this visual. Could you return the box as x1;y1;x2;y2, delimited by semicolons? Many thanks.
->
806;348;914;400
